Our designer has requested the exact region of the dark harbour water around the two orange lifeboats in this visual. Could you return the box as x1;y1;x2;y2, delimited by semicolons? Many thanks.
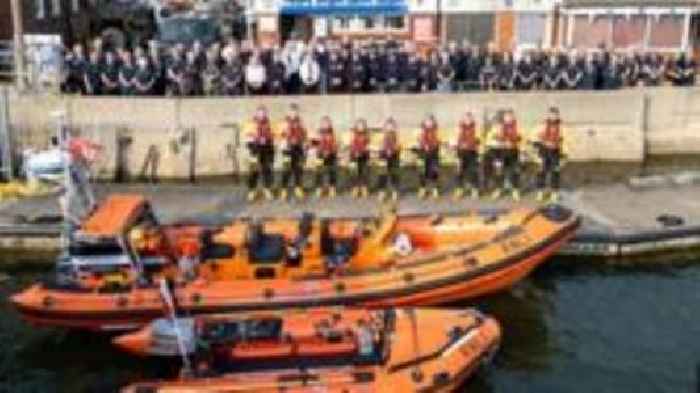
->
0;259;700;393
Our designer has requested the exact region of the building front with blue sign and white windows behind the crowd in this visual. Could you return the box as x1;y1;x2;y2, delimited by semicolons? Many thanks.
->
246;0;556;49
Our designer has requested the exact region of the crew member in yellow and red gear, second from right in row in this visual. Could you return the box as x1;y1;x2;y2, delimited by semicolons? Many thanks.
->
493;109;522;201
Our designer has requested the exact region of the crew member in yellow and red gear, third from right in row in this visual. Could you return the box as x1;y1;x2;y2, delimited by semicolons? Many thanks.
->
454;111;480;200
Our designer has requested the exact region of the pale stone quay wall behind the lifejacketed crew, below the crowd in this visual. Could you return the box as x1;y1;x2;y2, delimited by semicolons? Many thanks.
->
4;88;700;177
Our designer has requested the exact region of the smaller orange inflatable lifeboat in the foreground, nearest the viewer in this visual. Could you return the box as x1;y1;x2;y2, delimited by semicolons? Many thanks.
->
115;309;501;393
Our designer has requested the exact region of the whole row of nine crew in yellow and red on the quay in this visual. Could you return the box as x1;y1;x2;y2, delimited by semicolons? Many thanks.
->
247;104;564;202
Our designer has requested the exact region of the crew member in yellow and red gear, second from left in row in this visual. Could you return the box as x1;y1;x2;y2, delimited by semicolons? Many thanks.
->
280;104;306;200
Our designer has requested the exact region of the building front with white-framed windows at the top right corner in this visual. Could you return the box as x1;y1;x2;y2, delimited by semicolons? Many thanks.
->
559;0;700;55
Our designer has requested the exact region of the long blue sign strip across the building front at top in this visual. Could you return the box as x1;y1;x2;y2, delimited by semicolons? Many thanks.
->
280;0;408;15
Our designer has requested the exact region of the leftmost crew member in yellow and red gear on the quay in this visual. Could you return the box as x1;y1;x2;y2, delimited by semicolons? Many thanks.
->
248;106;275;202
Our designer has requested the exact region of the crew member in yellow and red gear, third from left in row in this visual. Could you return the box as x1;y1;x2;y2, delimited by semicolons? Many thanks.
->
314;116;338;198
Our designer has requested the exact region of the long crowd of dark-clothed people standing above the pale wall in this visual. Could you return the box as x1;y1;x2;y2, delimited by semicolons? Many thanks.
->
62;39;697;96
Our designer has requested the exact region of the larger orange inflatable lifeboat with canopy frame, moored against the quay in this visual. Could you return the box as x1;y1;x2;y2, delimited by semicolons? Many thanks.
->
12;195;579;330
